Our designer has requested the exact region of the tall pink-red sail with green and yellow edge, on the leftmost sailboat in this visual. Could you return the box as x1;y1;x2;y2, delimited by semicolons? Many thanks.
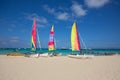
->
31;18;36;51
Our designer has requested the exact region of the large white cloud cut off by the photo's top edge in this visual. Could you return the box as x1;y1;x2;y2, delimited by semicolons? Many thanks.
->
85;0;110;8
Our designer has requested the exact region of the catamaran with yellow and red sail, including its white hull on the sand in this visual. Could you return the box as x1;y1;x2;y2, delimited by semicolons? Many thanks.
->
68;22;93;58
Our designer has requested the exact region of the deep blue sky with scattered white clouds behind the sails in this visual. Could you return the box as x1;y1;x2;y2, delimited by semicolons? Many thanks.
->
0;0;120;48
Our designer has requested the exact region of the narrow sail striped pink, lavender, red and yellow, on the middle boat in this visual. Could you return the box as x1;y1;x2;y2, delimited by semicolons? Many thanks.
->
48;25;55;51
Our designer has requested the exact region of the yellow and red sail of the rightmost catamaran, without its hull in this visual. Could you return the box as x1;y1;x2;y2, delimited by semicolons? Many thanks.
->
71;22;80;51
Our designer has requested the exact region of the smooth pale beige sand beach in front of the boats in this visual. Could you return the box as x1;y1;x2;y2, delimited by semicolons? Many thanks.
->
0;55;120;80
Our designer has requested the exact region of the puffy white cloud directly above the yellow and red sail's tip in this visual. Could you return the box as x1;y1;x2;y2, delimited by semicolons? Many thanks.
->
71;2;87;17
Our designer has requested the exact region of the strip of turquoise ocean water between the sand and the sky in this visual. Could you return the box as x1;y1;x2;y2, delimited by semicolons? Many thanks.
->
0;48;120;56
